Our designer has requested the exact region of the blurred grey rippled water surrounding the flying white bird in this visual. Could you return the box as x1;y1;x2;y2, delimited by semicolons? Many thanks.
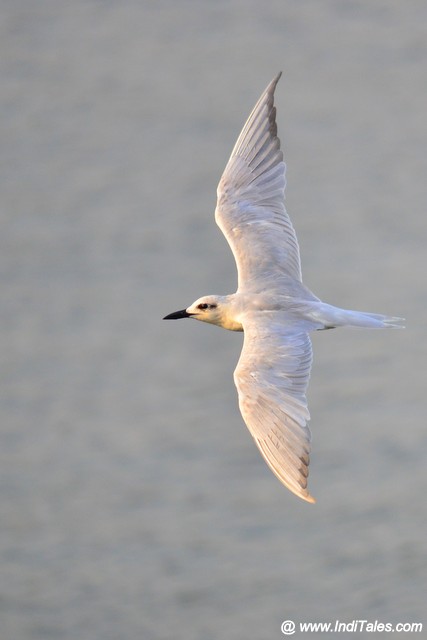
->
0;0;427;640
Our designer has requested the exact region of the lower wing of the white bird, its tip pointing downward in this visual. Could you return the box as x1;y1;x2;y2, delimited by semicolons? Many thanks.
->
234;313;315;502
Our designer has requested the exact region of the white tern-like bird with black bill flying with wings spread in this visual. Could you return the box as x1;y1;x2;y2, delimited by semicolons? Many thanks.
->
164;73;403;502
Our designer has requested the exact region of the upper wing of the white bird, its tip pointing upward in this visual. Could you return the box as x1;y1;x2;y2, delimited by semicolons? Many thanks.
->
215;73;301;290
